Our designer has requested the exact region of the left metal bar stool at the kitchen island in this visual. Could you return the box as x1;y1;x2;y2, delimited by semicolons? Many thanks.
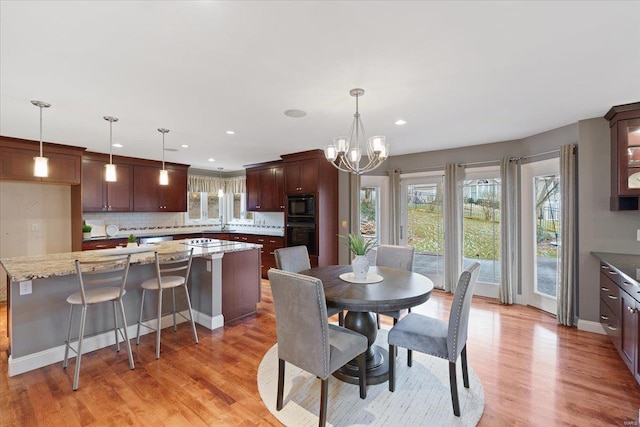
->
62;255;135;390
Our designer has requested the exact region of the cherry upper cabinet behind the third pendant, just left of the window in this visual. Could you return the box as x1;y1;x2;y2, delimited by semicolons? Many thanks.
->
133;164;187;212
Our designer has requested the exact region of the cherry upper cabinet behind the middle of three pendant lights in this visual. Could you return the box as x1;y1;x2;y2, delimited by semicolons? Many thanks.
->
82;155;133;212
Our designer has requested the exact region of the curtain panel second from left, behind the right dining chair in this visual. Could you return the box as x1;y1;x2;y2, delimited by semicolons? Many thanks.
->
444;163;464;292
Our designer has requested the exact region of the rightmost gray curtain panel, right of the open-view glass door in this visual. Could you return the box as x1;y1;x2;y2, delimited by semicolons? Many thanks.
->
557;144;577;326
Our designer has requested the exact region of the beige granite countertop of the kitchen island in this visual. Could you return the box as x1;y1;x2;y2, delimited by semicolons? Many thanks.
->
0;240;262;281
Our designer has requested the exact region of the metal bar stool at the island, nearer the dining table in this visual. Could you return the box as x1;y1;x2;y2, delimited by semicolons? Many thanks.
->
136;248;198;359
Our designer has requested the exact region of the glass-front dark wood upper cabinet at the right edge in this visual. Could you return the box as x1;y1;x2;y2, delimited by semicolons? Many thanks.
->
604;103;640;210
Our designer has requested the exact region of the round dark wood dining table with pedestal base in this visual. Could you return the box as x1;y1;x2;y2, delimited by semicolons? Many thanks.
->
300;265;433;384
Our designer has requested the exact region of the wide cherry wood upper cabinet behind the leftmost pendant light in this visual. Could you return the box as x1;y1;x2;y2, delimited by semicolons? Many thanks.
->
0;136;85;185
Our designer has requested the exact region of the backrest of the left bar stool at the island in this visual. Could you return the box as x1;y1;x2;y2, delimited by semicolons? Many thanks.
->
75;254;131;306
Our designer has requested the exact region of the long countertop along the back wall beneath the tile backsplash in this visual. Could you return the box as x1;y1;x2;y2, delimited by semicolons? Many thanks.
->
83;225;284;242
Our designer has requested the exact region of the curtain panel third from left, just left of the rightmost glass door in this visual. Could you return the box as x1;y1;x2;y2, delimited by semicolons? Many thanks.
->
500;157;520;304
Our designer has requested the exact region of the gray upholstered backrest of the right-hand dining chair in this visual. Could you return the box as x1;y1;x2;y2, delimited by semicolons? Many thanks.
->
447;262;480;362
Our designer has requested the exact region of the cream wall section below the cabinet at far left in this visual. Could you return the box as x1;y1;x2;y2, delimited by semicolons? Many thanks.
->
0;181;71;300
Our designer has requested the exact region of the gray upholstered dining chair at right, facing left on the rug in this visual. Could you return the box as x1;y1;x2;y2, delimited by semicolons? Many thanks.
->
388;262;480;417
